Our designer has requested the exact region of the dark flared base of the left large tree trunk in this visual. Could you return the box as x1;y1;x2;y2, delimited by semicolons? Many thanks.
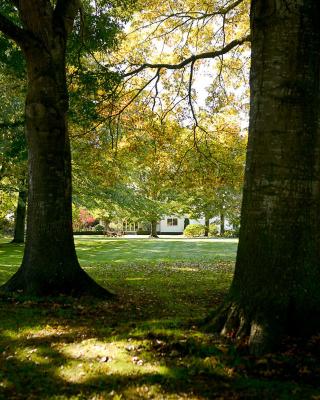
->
0;266;115;299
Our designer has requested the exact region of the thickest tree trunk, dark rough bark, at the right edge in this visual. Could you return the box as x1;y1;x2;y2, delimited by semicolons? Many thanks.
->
210;0;320;353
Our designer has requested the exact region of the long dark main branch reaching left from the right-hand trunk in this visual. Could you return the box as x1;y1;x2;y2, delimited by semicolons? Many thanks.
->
122;35;250;78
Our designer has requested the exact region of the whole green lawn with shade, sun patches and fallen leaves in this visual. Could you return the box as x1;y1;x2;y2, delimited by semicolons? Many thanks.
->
0;237;320;400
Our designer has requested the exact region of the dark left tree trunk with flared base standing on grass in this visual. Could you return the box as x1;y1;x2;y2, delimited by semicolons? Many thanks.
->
2;1;108;296
